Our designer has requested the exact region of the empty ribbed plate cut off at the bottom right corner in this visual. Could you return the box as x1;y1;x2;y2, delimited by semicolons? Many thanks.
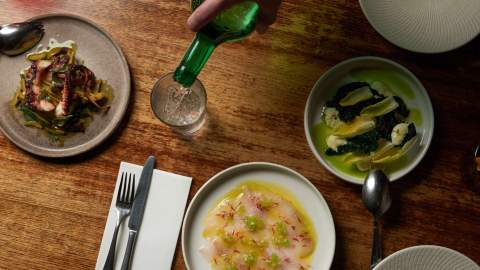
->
374;245;480;270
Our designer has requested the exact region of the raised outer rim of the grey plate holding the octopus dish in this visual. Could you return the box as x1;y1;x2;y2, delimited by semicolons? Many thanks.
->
0;13;132;158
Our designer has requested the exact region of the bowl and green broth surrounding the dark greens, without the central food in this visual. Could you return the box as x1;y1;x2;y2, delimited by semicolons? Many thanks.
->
304;56;434;184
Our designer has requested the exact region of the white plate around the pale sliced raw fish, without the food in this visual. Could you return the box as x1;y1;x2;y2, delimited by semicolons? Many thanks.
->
182;162;335;270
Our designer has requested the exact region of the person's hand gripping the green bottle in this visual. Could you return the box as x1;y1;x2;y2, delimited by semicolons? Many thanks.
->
187;0;282;33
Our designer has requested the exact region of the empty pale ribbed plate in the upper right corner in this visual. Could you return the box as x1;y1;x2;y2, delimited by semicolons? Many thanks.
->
359;0;480;53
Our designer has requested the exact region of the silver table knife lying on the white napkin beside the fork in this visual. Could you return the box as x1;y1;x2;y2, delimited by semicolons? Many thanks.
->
121;156;155;270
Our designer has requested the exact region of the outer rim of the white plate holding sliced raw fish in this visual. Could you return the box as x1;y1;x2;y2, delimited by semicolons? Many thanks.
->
181;162;336;270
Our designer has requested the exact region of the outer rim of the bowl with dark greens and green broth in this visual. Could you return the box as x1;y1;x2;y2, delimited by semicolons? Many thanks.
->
303;56;435;185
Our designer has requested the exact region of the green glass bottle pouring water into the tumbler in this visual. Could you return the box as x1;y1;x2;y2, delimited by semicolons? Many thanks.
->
173;0;259;87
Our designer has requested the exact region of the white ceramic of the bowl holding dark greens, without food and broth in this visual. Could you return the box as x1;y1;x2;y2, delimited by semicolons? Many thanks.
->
304;56;434;184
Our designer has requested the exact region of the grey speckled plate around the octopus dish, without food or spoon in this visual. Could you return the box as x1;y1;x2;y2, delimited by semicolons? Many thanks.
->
0;14;130;157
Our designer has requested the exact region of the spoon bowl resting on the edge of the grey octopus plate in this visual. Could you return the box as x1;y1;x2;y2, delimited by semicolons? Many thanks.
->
0;21;45;56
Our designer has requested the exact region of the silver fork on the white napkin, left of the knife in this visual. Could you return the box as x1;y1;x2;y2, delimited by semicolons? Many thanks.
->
103;172;135;270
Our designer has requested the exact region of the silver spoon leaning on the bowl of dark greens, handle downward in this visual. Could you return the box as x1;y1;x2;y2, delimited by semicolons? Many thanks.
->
362;170;392;268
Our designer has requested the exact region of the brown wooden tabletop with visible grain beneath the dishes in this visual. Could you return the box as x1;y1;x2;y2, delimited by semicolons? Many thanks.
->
0;0;480;270
